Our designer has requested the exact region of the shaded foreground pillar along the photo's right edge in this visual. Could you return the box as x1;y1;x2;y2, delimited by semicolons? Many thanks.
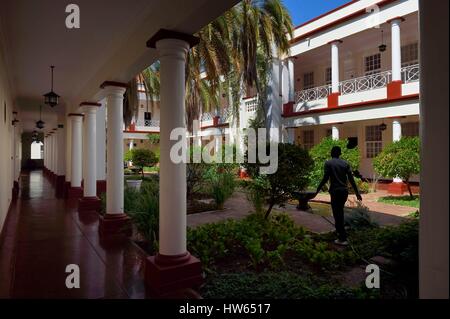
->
419;0;449;299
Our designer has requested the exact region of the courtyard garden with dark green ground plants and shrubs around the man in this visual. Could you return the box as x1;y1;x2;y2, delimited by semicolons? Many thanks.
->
103;139;419;299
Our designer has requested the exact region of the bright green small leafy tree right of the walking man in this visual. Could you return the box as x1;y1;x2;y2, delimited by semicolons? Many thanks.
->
373;137;420;198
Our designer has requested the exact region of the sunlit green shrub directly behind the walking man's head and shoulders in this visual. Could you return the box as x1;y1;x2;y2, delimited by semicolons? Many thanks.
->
309;137;361;189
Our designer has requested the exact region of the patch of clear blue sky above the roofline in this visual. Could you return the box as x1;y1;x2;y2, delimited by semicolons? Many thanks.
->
283;0;350;26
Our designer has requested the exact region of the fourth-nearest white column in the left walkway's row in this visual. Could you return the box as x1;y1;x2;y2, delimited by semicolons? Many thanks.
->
70;114;83;187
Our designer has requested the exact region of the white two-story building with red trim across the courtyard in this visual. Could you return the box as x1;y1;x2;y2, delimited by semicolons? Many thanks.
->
125;0;420;192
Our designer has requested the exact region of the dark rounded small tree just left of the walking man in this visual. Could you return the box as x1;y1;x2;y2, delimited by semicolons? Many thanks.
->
244;143;313;218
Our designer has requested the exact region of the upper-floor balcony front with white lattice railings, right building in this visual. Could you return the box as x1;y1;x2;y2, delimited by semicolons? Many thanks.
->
294;64;419;112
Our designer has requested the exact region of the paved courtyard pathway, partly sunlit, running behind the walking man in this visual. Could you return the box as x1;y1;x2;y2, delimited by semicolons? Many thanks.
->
187;191;417;233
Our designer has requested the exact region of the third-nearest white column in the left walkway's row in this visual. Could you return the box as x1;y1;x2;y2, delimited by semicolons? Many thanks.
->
82;105;98;197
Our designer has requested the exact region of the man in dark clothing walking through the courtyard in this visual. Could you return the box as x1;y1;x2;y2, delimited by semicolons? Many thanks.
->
316;146;362;245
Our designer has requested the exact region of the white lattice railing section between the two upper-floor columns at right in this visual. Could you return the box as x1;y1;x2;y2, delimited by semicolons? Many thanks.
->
339;71;392;95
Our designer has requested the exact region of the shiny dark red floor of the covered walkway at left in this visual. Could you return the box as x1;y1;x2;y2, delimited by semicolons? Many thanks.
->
0;171;146;298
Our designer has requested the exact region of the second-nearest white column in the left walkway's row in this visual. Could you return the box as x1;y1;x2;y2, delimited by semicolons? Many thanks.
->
105;86;125;215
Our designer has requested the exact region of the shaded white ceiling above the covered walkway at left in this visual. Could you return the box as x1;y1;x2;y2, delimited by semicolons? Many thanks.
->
0;0;239;130
